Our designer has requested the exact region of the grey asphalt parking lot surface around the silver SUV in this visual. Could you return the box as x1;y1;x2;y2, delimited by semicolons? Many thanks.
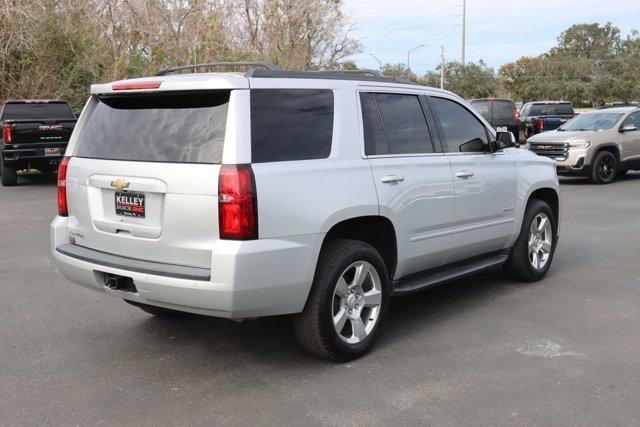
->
0;174;640;425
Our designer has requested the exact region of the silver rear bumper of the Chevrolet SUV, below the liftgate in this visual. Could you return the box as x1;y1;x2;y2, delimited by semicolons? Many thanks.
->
50;217;324;319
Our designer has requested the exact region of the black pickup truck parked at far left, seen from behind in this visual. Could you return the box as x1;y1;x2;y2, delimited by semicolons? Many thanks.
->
0;99;76;186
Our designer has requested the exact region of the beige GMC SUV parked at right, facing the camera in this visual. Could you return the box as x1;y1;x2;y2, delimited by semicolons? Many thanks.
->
527;107;640;184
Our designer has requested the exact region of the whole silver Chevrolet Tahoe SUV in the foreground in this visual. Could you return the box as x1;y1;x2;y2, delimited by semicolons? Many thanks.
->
51;64;561;360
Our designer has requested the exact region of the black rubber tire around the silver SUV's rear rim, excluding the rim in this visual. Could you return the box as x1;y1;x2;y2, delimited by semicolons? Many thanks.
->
293;239;389;361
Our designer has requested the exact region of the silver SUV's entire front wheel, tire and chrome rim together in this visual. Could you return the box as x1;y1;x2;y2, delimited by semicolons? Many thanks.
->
504;199;558;282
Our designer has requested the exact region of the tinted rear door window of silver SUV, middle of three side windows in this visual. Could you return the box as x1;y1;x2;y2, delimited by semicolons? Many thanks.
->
360;93;434;155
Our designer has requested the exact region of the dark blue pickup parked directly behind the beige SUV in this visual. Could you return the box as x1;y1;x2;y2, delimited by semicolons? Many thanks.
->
520;101;576;138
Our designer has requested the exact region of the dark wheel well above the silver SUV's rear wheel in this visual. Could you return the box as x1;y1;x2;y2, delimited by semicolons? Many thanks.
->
322;216;398;278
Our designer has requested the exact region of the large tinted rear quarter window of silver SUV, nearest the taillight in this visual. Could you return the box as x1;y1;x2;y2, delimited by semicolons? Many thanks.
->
251;89;333;163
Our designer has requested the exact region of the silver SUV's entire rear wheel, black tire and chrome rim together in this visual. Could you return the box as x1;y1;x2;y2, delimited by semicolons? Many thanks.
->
293;239;389;361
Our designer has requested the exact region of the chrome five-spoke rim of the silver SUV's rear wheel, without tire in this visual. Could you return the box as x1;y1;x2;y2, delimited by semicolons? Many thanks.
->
331;261;382;344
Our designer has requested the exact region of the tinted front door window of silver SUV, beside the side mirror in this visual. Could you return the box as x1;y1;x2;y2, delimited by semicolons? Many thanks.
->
431;97;488;153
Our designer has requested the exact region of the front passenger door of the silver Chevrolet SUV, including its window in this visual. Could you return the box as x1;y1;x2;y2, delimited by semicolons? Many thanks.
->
429;96;517;261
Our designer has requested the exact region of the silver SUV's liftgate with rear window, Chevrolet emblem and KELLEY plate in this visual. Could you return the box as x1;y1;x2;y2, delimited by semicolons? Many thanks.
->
67;90;235;268
